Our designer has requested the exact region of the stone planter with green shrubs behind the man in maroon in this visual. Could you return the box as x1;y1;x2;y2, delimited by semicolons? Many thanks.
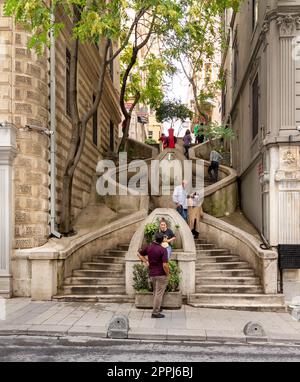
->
133;261;182;309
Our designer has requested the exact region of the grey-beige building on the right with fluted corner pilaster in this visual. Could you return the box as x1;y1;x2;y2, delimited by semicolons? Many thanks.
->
222;0;300;300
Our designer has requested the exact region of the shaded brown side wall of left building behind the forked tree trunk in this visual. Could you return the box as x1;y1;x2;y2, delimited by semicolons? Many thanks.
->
56;16;121;223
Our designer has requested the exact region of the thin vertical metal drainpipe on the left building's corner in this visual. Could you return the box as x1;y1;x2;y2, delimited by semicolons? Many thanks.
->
50;8;62;239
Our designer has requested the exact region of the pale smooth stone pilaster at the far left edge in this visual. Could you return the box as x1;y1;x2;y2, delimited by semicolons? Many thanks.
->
0;123;17;298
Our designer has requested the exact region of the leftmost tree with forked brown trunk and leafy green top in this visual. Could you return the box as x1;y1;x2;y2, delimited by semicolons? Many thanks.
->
4;0;146;235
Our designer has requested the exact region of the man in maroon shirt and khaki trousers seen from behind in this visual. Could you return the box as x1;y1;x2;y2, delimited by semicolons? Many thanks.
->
138;233;170;318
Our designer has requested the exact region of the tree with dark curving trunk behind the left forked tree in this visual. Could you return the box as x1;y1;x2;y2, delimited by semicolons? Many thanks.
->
119;0;185;151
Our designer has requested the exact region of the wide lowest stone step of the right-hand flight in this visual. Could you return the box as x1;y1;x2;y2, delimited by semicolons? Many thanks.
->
188;293;284;307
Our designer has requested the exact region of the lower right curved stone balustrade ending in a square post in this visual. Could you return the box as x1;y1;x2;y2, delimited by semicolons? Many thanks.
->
200;214;278;294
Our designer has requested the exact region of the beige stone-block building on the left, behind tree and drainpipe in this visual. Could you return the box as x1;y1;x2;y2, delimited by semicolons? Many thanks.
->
0;0;121;295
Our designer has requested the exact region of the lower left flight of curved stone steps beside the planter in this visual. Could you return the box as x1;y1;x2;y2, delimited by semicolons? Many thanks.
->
53;244;132;303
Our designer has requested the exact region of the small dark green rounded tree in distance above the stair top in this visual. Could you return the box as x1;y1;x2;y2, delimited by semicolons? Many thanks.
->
156;101;193;133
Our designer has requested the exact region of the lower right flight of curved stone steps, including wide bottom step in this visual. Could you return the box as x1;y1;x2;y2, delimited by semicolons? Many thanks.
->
188;239;285;312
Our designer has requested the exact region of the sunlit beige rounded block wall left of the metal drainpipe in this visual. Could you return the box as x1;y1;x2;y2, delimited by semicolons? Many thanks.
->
0;0;49;248
